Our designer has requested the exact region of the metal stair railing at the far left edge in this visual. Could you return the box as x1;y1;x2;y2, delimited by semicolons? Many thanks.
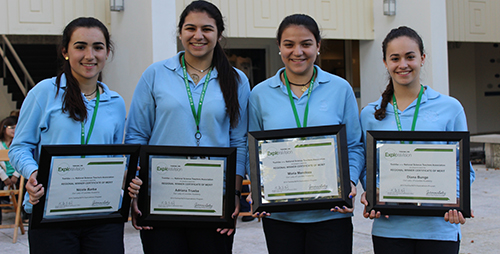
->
0;34;35;97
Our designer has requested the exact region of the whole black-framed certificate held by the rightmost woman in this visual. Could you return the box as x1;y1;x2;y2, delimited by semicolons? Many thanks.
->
366;131;471;217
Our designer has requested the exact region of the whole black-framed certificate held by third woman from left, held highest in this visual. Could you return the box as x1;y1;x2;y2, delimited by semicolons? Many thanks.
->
248;125;352;213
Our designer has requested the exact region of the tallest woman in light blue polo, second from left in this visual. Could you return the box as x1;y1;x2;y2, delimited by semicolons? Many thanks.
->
125;1;250;253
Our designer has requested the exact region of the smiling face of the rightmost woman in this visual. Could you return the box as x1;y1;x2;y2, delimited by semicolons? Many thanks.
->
384;36;425;87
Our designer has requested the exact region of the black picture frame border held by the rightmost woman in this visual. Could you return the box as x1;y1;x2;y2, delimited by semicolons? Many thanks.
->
366;131;471;218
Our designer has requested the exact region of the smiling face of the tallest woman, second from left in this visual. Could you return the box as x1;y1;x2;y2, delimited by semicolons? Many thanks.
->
179;12;220;62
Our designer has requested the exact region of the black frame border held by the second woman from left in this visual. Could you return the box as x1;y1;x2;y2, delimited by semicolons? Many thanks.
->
138;145;236;228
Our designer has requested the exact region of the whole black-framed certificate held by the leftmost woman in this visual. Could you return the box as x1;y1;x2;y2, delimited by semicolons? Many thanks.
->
31;145;140;228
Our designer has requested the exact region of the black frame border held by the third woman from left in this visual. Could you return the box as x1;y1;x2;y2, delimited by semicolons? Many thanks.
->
248;125;352;213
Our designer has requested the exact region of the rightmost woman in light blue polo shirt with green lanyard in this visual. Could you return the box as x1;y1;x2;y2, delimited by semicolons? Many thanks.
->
361;26;474;254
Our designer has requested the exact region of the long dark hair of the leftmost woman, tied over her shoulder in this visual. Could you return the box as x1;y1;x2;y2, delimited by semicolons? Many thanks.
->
56;17;113;122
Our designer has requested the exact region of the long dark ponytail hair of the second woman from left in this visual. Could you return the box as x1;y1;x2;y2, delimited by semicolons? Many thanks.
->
178;0;240;127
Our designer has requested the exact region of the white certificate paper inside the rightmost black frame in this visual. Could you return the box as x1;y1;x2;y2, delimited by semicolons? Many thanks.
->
378;144;457;204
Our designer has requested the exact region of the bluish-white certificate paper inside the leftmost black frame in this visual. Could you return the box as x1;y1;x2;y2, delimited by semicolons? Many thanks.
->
45;157;127;216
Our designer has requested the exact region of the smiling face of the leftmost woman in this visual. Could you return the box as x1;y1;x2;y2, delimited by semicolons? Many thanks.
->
63;27;109;84
